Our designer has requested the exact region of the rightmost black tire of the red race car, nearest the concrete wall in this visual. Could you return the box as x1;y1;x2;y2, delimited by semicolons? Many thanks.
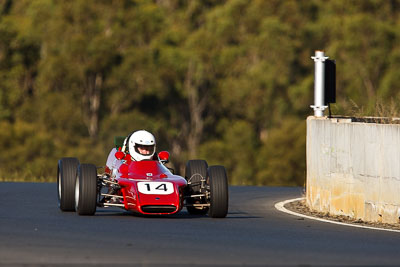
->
208;166;229;218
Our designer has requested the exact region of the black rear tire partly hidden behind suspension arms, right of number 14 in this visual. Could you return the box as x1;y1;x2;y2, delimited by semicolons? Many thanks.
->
185;159;208;215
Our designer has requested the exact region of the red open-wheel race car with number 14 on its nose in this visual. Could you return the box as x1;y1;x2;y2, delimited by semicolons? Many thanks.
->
57;137;228;218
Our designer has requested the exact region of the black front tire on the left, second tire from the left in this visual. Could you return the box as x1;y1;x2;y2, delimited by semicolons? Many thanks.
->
75;164;97;215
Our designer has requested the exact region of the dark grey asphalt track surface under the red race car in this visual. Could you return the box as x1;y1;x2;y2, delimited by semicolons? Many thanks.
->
0;183;400;266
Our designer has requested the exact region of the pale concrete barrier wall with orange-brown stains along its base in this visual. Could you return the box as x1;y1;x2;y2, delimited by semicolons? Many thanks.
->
306;117;400;223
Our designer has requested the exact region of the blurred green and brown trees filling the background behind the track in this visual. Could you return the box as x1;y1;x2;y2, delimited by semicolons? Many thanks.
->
0;0;400;185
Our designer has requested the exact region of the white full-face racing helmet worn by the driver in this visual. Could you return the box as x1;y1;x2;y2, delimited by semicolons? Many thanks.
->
128;130;156;161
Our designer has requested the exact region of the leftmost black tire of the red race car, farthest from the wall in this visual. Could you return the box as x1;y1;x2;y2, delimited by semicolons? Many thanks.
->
57;158;79;211
